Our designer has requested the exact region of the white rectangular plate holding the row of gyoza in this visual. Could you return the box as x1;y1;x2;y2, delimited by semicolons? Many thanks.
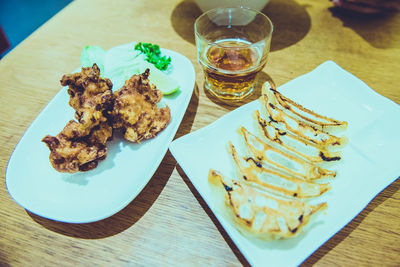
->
170;61;400;266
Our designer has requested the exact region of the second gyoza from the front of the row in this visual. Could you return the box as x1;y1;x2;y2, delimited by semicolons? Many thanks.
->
229;142;331;198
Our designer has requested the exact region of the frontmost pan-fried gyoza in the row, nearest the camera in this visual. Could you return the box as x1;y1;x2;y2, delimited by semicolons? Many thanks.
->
208;170;327;240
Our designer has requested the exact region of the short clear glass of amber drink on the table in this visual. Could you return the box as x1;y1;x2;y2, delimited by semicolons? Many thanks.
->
195;8;272;100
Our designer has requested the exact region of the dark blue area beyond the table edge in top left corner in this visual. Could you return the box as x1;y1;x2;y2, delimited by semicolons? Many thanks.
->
0;0;72;58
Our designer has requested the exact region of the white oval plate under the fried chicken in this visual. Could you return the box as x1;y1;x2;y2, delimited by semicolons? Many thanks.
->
6;46;195;223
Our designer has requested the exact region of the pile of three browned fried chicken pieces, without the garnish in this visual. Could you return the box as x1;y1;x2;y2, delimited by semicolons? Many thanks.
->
42;63;171;173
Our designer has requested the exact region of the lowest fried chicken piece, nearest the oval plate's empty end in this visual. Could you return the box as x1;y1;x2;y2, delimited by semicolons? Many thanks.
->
42;120;113;173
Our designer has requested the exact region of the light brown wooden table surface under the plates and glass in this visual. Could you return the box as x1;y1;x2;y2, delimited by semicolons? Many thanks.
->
0;0;400;266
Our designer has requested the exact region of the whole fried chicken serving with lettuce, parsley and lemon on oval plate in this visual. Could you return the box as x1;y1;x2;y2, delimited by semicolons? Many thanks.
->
42;39;180;173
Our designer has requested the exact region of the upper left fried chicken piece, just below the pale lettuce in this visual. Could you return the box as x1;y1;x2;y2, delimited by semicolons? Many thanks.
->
60;64;114;136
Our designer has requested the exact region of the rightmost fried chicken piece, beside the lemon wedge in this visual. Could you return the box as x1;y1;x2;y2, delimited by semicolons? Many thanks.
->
112;69;171;142
